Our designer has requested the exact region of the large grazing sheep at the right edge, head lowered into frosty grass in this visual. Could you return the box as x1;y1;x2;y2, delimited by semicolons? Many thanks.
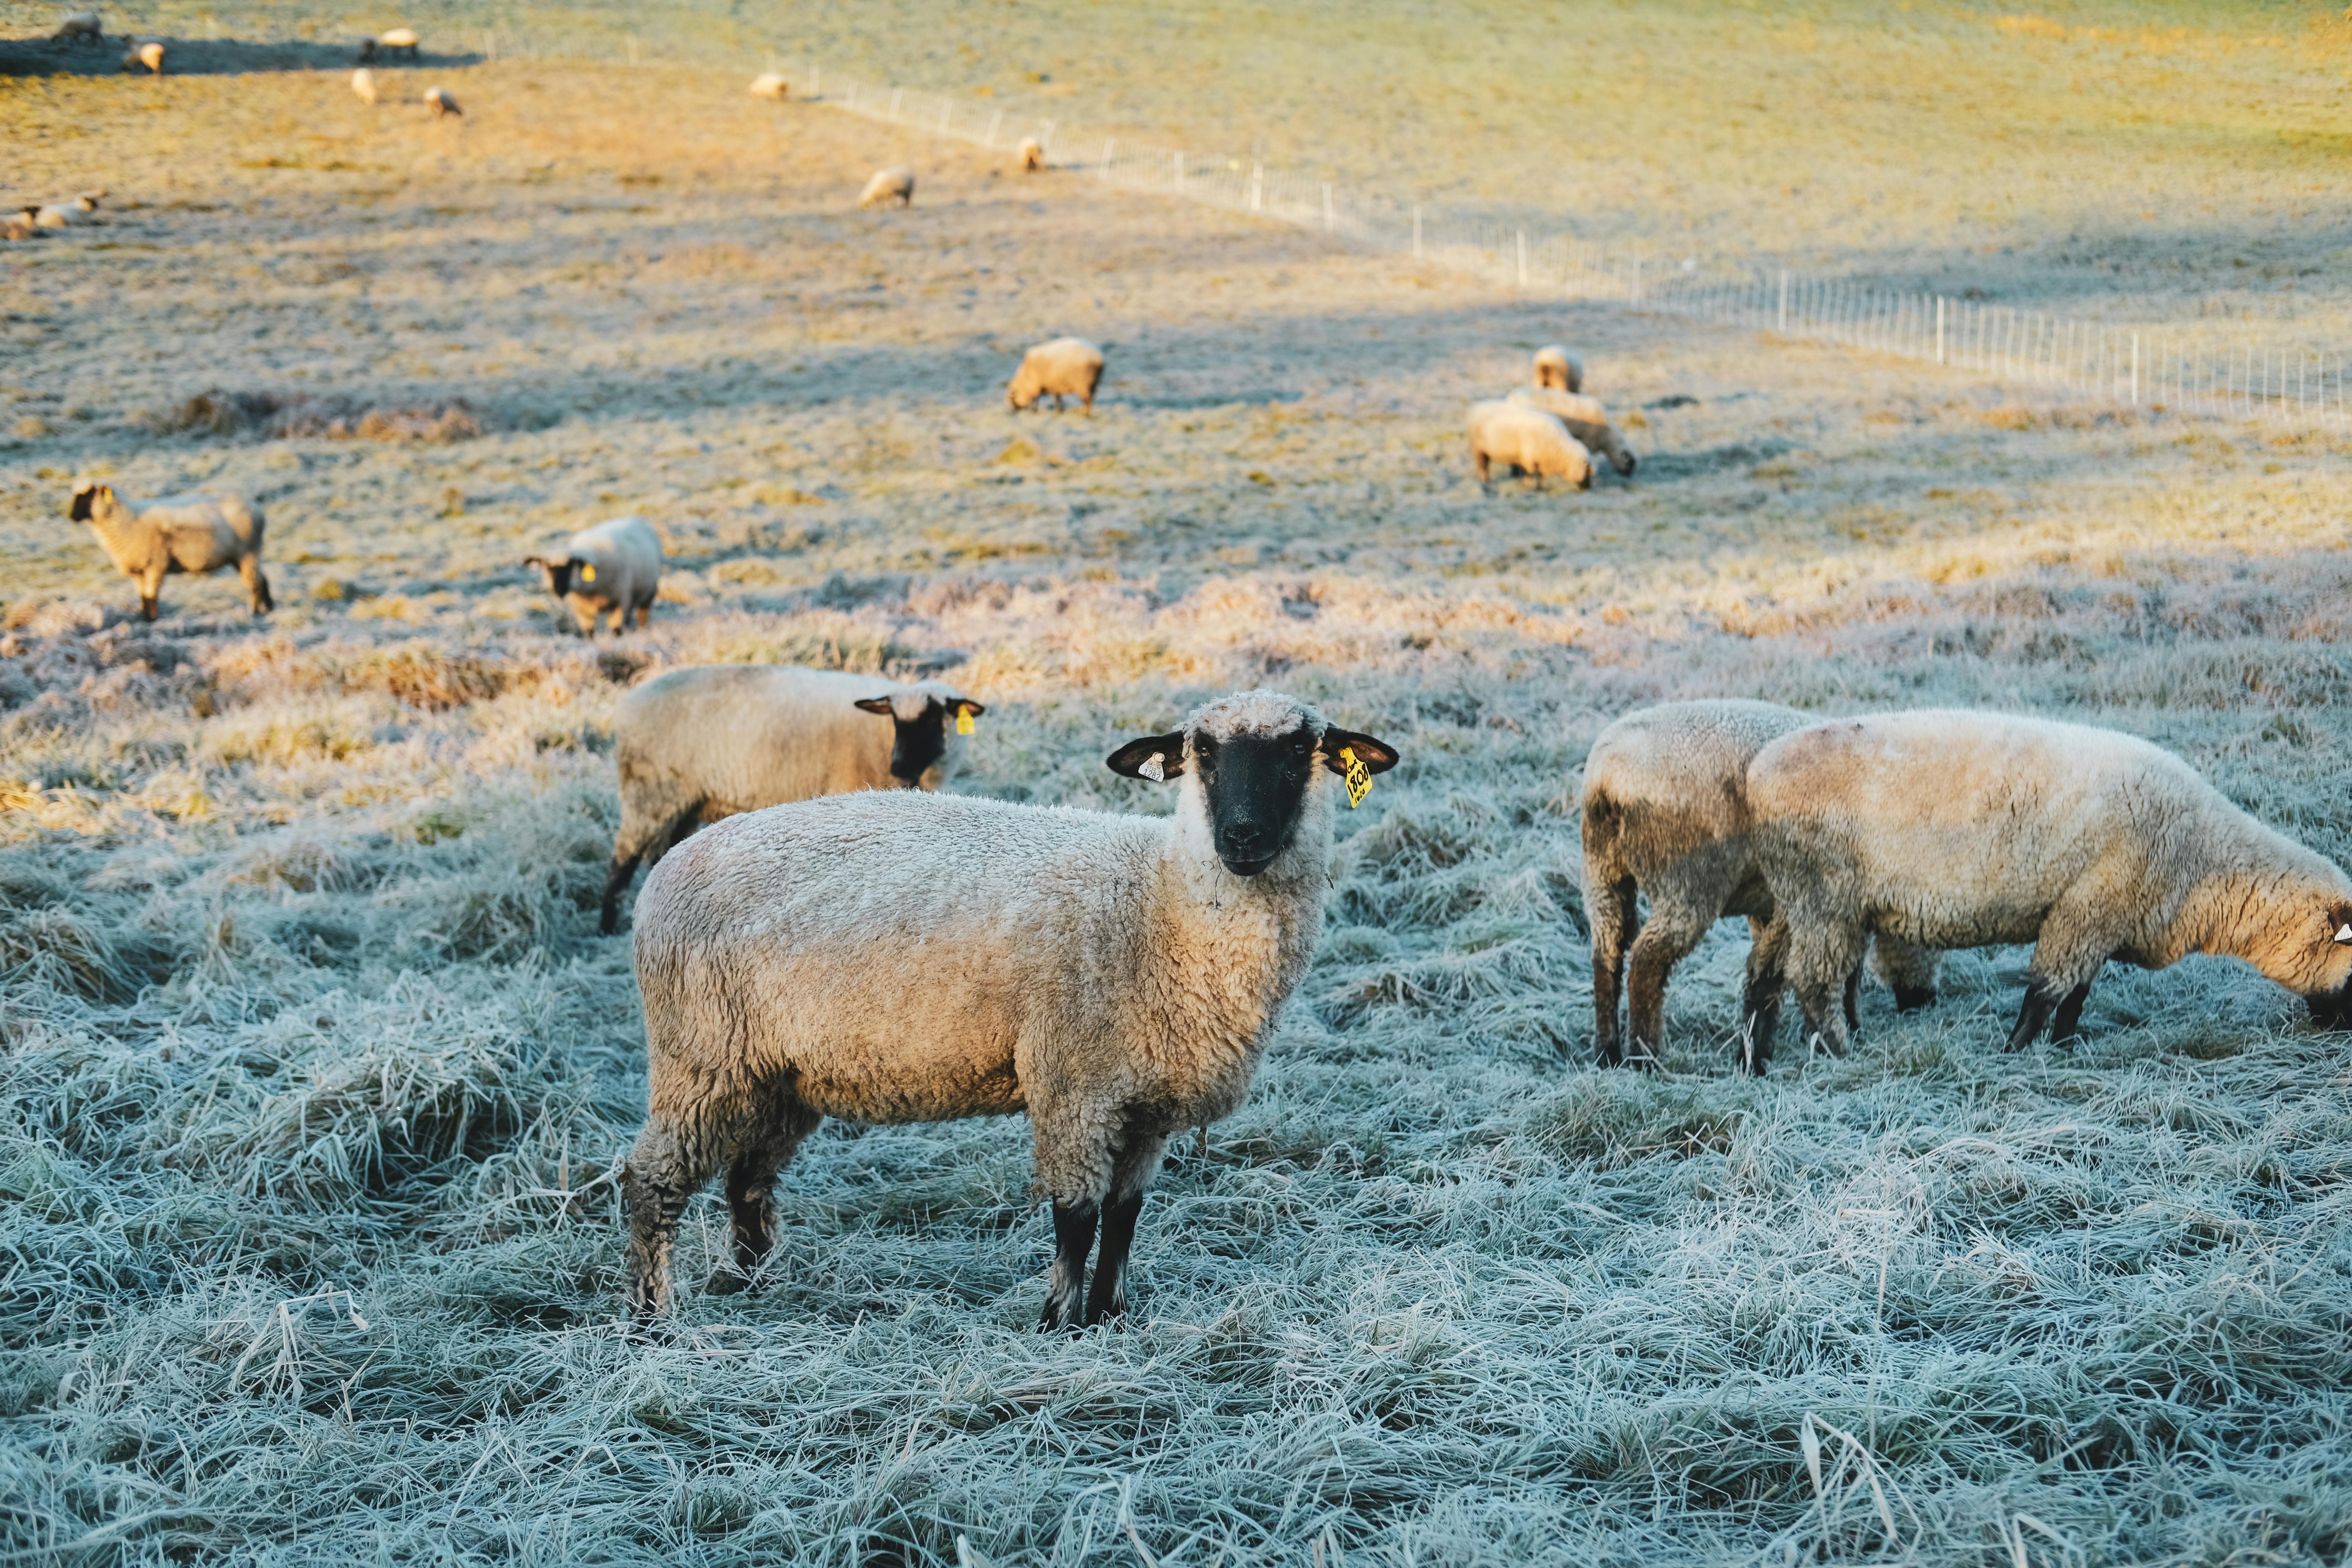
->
1748;710;2352;1056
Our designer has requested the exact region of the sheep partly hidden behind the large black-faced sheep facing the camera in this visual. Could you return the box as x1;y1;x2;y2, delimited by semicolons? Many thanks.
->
602;665;988;936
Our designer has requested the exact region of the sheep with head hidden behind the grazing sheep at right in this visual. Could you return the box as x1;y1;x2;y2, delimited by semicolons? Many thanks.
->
1578;698;1936;1072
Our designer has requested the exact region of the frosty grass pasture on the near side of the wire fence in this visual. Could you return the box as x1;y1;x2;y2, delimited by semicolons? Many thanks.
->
0;24;2352;1568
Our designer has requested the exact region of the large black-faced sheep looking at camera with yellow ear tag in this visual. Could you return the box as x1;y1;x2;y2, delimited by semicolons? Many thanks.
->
623;691;1397;1331
